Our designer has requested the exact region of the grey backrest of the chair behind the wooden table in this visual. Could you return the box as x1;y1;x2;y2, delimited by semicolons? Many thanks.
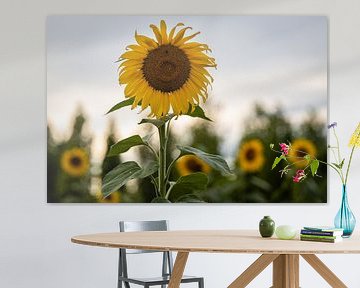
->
119;220;169;254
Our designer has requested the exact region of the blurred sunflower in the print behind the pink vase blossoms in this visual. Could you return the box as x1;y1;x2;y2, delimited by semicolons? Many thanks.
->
288;138;317;168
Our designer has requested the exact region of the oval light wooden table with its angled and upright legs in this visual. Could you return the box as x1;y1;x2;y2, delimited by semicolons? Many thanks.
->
71;230;360;288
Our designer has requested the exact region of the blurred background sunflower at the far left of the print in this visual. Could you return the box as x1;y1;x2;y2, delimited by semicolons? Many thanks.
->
60;148;90;177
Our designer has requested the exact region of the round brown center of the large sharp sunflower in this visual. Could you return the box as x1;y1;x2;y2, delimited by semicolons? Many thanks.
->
142;45;190;92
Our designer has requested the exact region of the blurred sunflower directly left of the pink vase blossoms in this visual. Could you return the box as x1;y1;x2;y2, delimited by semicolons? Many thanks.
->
238;139;265;173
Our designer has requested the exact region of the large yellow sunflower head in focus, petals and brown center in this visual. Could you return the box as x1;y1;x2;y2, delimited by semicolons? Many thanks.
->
119;20;216;118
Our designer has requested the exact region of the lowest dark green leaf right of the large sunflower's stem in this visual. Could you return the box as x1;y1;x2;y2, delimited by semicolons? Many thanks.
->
169;172;209;202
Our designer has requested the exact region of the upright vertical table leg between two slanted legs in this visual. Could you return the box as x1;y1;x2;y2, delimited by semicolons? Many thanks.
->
272;254;299;288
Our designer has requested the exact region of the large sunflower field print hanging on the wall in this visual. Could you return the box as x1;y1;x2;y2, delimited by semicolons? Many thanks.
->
47;16;328;203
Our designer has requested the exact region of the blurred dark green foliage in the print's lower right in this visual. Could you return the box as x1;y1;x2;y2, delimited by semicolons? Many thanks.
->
202;105;327;203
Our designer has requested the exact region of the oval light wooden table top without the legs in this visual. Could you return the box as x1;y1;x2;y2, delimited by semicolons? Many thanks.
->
71;230;360;254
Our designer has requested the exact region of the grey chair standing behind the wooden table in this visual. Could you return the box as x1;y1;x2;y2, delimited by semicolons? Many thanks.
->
118;220;204;288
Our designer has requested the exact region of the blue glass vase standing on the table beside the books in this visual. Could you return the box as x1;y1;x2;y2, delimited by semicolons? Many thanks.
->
334;185;356;238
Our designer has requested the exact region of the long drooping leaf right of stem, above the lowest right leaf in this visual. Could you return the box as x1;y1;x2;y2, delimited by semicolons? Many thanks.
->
176;145;232;175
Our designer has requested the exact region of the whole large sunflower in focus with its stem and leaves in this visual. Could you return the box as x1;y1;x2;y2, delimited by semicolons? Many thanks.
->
102;20;231;203
